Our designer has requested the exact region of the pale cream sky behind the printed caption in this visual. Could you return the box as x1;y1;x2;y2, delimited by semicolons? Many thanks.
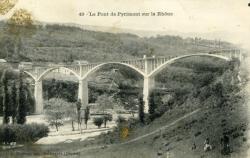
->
0;0;250;50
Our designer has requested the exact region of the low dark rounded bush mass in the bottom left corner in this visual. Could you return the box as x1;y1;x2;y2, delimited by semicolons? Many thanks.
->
0;123;49;144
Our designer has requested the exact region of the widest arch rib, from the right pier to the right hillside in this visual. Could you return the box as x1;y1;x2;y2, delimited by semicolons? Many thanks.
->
148;54;230;77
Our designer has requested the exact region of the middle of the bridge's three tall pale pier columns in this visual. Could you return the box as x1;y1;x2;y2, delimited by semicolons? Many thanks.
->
78;78;89;107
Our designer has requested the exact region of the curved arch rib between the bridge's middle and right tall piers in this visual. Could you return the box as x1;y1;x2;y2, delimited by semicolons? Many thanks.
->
81;62;146;80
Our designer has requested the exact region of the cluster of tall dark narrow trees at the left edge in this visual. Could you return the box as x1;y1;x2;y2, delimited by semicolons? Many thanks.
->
0;68;31;124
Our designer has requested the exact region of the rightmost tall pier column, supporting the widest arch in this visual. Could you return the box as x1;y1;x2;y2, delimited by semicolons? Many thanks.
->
143;76;155;113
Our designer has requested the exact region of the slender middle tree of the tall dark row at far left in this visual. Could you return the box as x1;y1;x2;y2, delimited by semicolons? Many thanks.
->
10;82;17;124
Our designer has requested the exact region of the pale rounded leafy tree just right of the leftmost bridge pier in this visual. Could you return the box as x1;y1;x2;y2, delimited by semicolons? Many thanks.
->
45;98;68;131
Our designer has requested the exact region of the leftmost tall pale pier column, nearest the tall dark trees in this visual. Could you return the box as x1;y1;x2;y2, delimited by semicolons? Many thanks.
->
34;81;43;114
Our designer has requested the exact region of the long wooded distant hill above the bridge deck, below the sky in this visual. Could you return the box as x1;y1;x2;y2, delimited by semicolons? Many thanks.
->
0;22;235;62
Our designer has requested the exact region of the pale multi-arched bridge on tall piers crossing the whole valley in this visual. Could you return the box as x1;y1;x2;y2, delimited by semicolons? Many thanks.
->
20;50;243;114
